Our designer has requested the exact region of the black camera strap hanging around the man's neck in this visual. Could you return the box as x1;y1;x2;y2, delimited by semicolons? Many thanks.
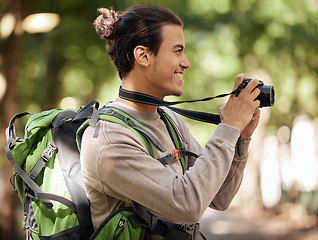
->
119;87;241;125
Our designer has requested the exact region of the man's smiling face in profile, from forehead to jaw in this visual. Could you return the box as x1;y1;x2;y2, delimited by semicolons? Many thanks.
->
148;24;190;99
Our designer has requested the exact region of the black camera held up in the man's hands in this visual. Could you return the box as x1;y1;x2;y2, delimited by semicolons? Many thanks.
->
236;78;275;108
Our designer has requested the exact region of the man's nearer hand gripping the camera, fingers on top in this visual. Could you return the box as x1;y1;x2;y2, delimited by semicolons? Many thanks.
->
219;73;260;132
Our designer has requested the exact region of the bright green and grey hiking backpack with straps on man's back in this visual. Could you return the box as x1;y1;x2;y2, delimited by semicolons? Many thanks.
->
5;100;194;240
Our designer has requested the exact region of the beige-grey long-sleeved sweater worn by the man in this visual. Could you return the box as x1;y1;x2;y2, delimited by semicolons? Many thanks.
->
81;102;249;228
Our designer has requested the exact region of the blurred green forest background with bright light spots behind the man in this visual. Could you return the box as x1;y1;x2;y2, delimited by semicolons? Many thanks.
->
0;0;318;240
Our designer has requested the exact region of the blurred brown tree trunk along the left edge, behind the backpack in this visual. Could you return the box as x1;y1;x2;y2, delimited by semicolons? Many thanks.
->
0;0;30;240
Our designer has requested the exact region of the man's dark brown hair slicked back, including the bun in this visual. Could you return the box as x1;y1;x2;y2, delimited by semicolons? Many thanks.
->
94;5;182;79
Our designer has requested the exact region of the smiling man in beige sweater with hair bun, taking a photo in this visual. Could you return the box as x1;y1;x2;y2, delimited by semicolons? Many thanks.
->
81;5;260;239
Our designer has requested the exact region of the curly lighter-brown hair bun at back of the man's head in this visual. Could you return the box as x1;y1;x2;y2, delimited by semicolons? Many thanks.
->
94;8;120;40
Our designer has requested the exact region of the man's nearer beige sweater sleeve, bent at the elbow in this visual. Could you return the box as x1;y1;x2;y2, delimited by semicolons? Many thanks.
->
81;117;245;223
